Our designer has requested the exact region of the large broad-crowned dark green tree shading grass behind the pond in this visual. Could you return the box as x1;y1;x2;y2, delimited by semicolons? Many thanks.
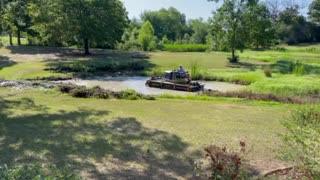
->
30;0;127;55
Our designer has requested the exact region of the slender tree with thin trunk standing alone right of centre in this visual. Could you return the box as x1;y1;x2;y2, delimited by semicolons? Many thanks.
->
209;0;255;63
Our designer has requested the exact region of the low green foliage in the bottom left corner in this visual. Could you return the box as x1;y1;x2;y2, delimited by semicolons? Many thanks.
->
0;164;80;180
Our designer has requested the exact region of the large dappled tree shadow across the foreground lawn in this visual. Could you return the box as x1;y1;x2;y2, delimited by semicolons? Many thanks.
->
0;98;192;179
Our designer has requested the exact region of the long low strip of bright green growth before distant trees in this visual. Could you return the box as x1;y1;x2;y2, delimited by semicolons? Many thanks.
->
164;44;208;52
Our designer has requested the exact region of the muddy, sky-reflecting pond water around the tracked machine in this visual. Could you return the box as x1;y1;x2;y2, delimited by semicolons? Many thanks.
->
59;76;244;95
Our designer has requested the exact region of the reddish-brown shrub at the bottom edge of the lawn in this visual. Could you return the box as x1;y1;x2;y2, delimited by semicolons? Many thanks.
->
195;141;247;180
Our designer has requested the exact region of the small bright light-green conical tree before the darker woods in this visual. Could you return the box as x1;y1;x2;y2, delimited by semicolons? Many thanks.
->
138;21;155;51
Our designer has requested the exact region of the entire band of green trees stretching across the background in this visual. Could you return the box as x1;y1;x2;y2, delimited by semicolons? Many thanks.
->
0;0;320;59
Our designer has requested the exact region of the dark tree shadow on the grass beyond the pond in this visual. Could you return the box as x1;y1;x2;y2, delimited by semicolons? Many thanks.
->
46;52;156;77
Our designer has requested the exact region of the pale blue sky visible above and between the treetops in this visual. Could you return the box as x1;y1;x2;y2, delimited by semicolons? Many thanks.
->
121;0;312;19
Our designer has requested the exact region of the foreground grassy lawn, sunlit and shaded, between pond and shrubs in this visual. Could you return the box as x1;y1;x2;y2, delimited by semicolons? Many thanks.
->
0;88;291;179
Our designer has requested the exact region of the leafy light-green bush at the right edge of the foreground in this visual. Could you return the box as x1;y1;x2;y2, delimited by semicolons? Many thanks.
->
282;105;320;179
